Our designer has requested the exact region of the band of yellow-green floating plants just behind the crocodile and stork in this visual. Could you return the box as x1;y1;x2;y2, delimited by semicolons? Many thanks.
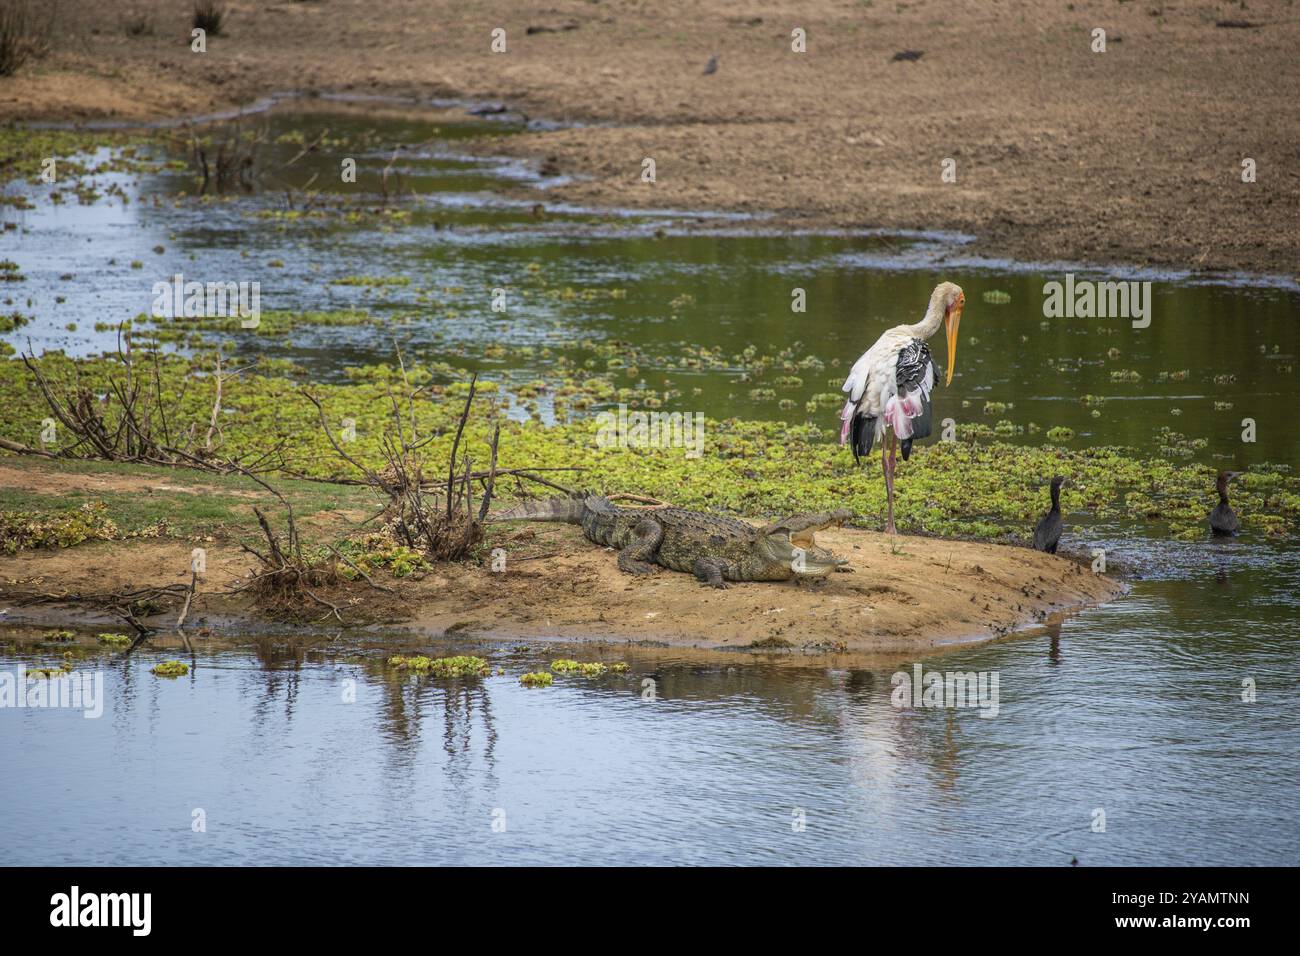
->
0;353;1300;546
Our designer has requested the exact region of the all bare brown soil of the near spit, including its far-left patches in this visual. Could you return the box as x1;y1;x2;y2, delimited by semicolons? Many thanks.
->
0;468;1121;653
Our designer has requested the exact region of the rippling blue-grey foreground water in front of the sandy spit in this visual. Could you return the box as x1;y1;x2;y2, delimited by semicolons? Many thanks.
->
0;538;1300;865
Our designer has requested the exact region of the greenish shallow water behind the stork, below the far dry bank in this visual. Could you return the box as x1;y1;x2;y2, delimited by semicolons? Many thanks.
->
0;108;1300;467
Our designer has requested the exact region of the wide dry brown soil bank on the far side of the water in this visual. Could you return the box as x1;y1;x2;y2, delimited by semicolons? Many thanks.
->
0;0;1300;274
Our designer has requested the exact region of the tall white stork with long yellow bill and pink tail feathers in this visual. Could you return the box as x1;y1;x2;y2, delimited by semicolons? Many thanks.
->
840;282;966;535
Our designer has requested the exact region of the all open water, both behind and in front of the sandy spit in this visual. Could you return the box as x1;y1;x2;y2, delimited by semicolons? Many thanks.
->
0;112;1300;865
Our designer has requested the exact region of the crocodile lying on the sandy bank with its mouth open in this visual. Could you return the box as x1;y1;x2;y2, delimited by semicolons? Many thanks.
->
489;494;852;588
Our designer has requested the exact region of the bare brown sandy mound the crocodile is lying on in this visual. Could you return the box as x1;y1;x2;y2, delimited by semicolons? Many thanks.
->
390;527;1119;653
